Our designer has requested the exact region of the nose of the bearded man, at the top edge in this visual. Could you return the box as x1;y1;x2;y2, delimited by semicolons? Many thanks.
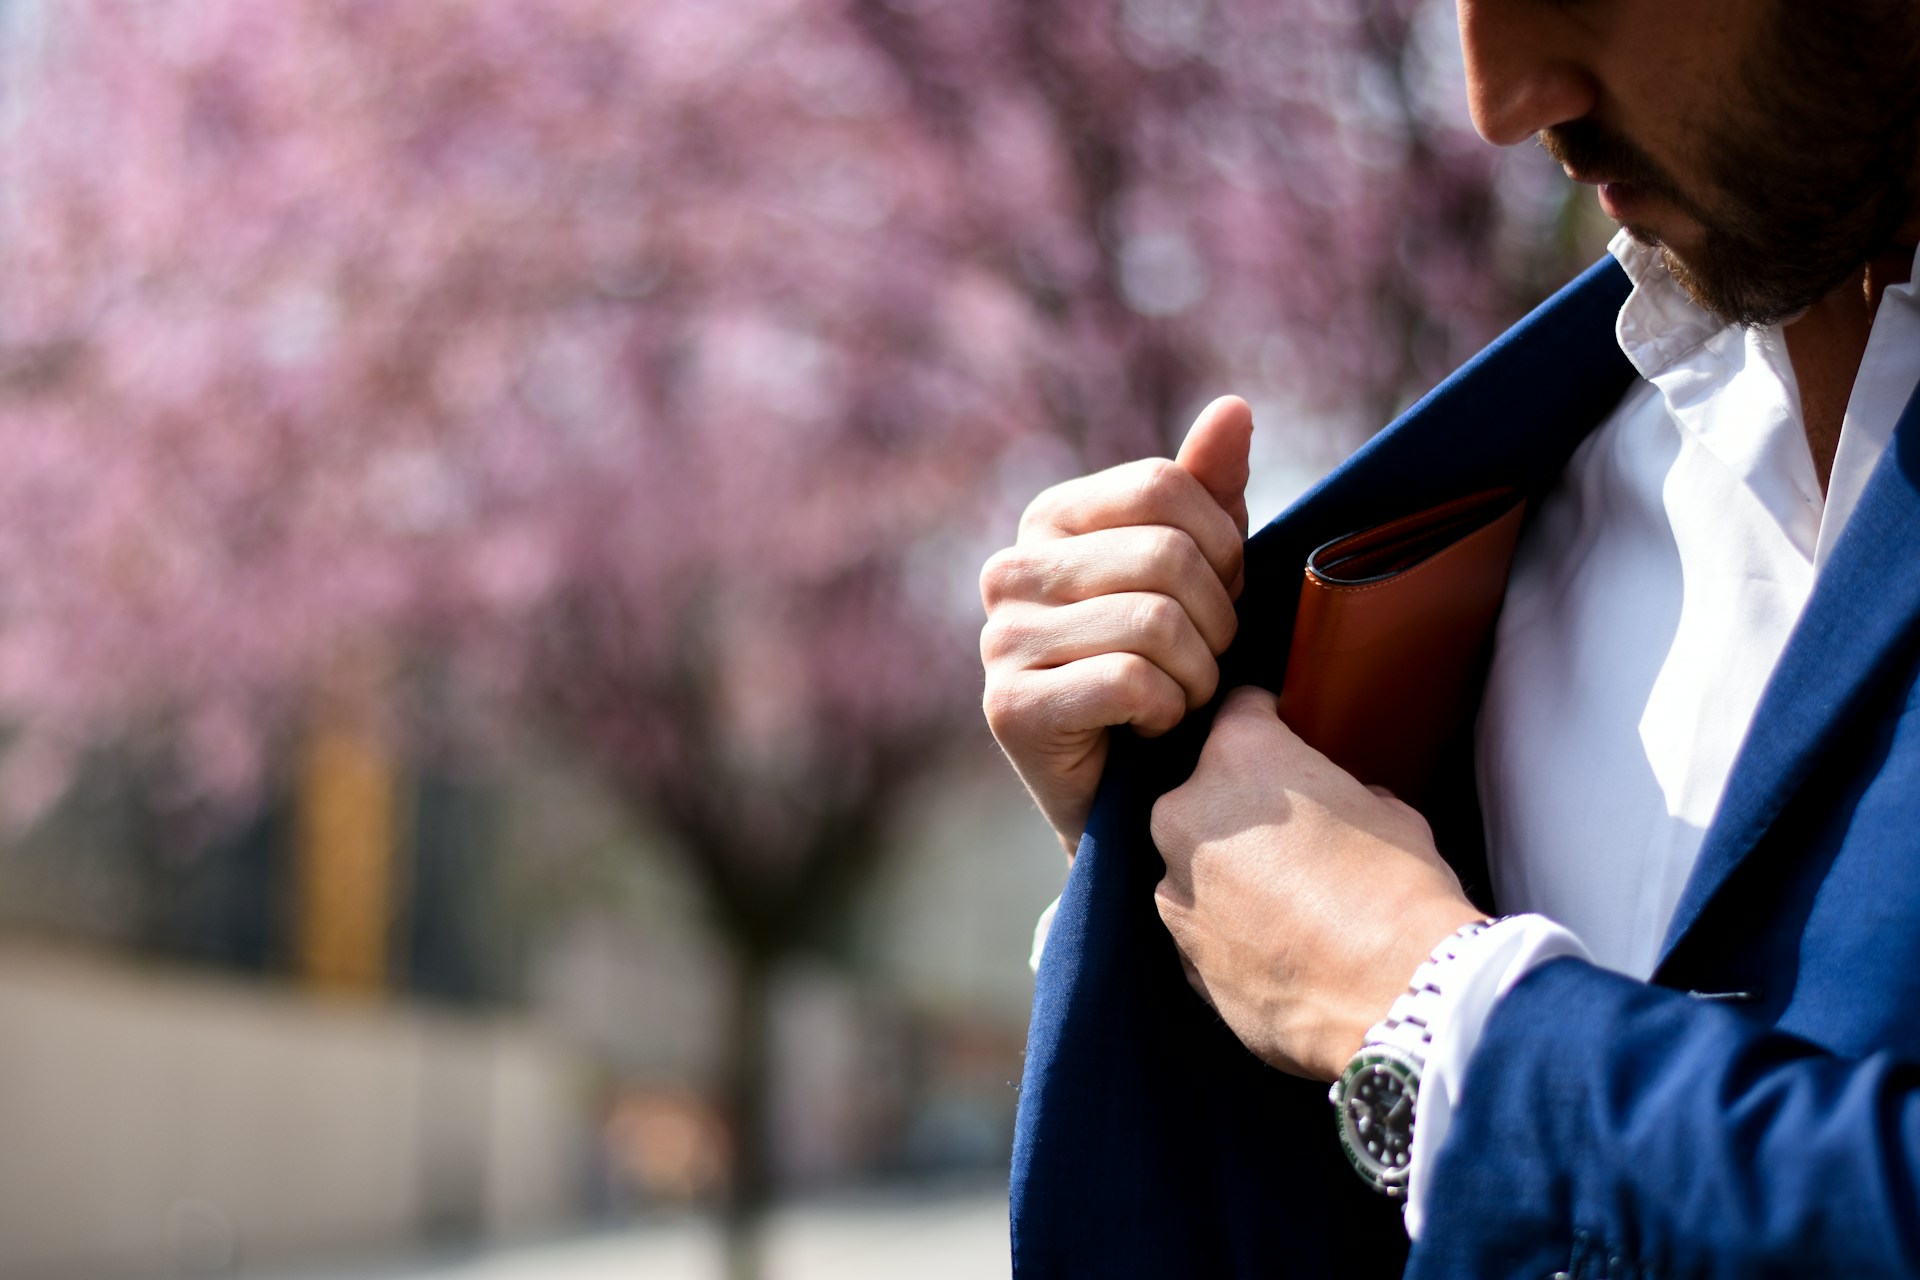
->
1457;0;1599;146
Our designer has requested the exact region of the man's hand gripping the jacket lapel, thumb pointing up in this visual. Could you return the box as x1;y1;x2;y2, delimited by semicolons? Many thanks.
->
979;395;1254;856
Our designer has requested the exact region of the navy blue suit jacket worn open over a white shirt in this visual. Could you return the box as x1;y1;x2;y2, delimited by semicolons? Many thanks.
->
1014;261;1920;1280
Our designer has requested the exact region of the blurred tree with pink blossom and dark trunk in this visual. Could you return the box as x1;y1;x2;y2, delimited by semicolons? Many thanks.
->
0;0;1582;1276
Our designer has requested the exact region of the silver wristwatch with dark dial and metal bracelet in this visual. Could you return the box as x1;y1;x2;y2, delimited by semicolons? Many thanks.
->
1327;919;1494;1199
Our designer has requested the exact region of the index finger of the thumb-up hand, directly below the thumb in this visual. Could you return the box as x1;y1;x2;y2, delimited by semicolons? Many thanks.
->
1020;459;1244;583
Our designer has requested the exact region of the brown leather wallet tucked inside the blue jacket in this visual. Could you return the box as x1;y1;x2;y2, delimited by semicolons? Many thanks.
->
1281;489;1526;808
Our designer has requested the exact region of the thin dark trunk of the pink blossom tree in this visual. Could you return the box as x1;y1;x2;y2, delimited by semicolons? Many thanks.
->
722;938;774;1280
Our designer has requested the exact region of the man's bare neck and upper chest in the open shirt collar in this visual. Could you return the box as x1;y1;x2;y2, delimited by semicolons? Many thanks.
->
1784;239;1920;493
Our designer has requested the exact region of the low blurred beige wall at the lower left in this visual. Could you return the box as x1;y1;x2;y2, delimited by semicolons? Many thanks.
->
0;946;586;1280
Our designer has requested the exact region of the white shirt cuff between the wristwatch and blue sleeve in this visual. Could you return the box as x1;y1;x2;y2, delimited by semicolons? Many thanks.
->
1405;915;1590;1240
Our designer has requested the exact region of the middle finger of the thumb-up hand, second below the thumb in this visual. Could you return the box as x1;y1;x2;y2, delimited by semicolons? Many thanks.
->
979;524;1238;654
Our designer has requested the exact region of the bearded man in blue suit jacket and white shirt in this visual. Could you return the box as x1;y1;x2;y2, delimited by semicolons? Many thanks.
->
981;0;1920;1278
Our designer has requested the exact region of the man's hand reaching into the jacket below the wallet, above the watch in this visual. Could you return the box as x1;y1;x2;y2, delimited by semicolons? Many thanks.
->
1152;687;1484;1080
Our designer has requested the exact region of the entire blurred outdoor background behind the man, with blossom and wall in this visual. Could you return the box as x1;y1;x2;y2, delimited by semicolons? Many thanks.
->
0;0;1605;1280
